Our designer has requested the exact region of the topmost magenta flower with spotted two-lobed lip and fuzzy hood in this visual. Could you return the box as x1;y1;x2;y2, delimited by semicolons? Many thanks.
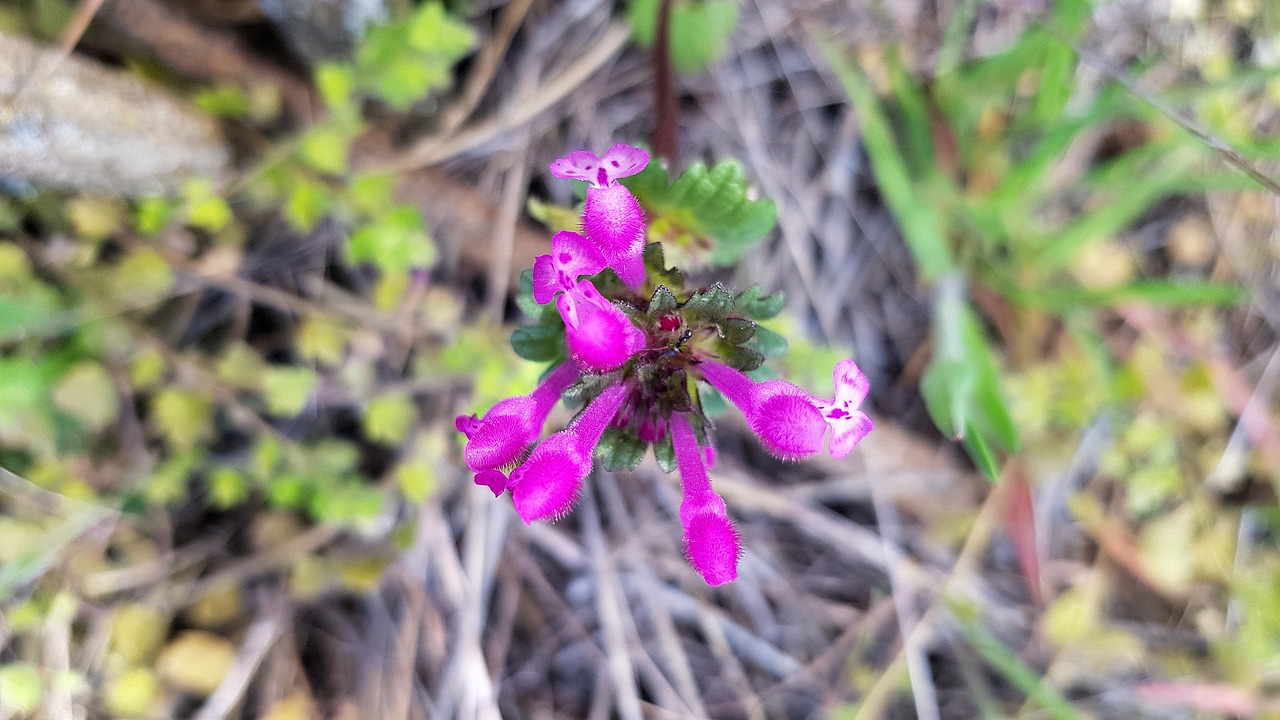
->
550;143;649;290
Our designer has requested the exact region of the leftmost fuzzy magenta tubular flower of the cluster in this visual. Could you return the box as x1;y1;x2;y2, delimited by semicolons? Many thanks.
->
453;361;580;497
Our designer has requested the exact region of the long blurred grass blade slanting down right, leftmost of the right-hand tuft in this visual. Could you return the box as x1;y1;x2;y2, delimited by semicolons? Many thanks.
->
819;41;954;282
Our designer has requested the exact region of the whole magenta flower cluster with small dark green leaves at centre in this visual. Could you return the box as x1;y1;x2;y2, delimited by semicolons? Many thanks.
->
457;145;872;585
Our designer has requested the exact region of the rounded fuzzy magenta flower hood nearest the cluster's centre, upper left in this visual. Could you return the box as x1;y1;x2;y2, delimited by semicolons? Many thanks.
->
556;281;644;373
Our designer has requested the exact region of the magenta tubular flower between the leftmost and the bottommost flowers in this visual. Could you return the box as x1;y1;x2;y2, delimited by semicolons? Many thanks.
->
509;383;626;524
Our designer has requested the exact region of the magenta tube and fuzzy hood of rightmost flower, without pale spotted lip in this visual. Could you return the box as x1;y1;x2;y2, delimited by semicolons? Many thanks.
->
698;360;827;460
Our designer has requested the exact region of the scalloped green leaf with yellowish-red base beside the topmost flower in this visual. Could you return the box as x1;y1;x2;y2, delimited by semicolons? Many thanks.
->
622;160;778;265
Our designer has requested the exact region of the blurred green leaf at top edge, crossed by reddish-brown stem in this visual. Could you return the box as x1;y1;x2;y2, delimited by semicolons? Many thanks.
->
627;0;737;73
